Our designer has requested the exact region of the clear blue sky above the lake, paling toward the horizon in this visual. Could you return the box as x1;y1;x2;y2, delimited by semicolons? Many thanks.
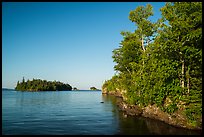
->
2;2;165;89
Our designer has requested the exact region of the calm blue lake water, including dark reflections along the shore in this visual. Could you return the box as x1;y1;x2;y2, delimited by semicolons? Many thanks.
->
2;90;201;135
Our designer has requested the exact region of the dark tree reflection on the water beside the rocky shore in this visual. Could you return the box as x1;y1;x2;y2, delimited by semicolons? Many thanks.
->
102;94;201;135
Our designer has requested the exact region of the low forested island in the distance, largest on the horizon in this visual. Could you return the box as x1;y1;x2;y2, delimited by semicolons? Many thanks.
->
15;78;72;91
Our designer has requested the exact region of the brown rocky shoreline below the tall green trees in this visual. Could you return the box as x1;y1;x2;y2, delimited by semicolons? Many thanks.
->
102;90;202;130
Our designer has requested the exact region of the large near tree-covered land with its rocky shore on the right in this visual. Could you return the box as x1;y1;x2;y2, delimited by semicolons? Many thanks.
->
102;2;202;129
